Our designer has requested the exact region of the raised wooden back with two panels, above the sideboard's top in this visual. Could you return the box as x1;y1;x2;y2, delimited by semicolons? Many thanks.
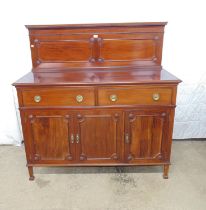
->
27;23;166;72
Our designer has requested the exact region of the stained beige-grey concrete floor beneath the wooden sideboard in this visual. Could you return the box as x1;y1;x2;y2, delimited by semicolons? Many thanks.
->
0;141;206;210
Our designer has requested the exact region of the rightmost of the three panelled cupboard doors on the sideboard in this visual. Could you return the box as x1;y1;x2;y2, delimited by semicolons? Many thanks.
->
125;110;169;163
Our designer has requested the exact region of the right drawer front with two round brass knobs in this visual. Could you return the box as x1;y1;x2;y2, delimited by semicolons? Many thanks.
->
98;87;172;106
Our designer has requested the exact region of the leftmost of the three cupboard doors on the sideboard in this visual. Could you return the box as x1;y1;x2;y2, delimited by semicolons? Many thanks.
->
27;111;75;163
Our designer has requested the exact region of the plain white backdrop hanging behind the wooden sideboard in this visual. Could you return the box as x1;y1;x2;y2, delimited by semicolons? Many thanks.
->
0;0;206;145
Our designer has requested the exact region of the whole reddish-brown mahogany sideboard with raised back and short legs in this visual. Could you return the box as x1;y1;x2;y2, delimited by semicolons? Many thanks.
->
13;22;181;180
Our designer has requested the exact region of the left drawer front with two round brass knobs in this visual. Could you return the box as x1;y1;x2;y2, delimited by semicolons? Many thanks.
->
22;87;95;106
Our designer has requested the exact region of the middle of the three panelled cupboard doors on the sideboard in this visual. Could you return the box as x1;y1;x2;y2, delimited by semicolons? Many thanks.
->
75;110;122;163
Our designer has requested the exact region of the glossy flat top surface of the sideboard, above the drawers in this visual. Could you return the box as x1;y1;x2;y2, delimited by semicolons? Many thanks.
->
13;70;181;86
